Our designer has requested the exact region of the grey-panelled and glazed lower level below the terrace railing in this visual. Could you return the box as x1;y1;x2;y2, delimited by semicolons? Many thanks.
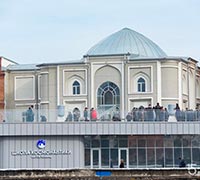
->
0;122;200;169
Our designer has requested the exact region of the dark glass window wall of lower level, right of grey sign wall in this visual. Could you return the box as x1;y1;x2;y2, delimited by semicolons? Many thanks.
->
85;135;200;168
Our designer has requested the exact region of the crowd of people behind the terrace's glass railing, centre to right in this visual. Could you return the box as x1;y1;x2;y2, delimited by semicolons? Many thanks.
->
66;103;200;121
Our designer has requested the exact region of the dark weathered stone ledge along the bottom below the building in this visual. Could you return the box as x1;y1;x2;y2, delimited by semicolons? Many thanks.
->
0;168;200;180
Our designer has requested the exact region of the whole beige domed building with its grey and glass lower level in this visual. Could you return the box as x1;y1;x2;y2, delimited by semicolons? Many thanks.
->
0;28;200;168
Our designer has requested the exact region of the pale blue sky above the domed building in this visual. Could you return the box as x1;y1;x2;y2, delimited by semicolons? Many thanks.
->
0;0;200;64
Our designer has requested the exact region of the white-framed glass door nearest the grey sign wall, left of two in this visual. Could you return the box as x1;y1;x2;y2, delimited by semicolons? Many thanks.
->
91;148;101;168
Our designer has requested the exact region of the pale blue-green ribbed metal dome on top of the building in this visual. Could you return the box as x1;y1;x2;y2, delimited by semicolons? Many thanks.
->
87;28;167;57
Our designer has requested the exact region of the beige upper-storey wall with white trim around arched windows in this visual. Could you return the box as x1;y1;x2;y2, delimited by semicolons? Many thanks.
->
5;57;200;119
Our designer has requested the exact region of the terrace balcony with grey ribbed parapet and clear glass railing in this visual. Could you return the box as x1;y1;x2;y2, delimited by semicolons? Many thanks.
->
0;109;200;136
